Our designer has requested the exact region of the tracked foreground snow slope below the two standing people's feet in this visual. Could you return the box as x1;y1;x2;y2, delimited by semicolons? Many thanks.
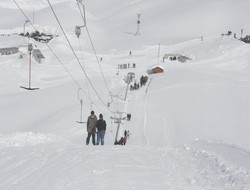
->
0;140;250;190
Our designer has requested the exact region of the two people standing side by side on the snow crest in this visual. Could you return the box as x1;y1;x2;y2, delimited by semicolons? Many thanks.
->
86;111;106;145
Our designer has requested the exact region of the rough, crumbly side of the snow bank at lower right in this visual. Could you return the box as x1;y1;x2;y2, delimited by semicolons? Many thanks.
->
185;145;250;189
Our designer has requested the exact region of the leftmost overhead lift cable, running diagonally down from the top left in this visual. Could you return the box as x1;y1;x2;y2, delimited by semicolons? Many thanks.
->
13;0;103;112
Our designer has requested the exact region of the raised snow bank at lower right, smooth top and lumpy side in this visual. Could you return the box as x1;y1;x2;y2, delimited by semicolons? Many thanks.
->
184;140;250;187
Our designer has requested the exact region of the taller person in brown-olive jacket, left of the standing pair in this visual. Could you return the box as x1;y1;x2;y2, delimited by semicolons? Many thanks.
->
86;111;97;145
